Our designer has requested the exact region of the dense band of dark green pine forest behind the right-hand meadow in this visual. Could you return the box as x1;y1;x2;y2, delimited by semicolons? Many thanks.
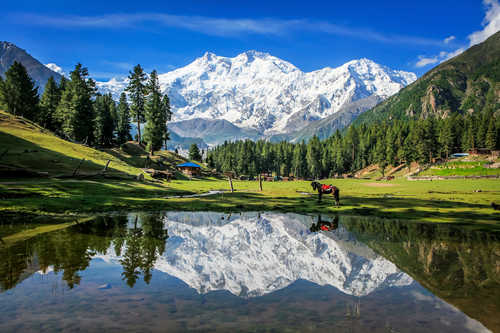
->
207;111;500;178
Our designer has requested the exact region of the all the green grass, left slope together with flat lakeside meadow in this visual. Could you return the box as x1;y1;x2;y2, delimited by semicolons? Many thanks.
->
0;111;500;228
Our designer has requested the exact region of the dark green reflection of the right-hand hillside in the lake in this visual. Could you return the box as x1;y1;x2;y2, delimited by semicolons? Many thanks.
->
342;217;500;332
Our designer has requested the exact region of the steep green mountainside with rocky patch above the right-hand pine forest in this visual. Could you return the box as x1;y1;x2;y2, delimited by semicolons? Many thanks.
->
354;32;500;125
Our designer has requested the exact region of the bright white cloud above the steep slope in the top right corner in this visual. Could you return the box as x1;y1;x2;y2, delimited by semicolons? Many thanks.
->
415;0;500;67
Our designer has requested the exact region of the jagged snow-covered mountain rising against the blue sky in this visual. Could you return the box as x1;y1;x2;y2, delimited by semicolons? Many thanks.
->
98;51;417;134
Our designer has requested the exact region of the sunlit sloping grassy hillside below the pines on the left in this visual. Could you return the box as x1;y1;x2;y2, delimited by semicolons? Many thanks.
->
0;111;191;178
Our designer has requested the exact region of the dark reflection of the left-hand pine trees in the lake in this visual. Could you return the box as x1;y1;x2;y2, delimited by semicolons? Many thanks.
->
0;214;168;291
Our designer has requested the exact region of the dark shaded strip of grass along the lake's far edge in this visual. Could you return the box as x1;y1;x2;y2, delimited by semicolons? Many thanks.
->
0;175;500;228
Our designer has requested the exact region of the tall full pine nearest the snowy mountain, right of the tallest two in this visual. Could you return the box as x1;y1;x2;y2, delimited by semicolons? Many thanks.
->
144;71;166;154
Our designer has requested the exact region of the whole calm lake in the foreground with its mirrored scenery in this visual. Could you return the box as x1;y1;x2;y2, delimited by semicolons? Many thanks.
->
0;212;500;333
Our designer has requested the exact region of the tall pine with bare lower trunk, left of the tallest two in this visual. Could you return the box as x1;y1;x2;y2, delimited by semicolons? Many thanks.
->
125;65;147;143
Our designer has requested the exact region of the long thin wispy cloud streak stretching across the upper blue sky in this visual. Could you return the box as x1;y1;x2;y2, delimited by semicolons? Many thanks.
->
8;13;444;46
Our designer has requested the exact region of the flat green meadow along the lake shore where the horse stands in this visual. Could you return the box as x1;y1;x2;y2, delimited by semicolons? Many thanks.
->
0;178;500;228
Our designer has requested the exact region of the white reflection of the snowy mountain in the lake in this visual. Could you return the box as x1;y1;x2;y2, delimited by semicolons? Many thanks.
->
98;212;413;297
